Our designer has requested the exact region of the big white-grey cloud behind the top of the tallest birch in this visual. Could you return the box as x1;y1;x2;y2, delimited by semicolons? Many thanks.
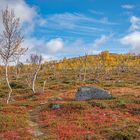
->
0;0;47;34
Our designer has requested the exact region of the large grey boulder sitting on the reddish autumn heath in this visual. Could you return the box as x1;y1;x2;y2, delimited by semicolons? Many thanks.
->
75;86;112;101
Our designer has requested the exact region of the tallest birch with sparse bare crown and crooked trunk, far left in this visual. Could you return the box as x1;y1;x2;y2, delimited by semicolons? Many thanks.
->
0;7;24;104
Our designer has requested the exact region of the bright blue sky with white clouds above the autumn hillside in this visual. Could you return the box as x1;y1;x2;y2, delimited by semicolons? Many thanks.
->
0;0;140;59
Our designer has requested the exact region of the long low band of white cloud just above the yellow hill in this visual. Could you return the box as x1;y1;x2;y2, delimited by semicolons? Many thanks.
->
24;35;110;60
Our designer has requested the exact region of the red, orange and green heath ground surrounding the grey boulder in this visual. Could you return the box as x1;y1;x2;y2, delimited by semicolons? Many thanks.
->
0;55;140;140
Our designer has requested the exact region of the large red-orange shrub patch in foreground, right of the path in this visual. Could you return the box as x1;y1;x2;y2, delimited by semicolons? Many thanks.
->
40;105;135;140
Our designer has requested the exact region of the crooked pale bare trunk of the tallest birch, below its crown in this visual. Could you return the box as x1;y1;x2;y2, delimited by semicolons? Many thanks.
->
5;64;12;104
